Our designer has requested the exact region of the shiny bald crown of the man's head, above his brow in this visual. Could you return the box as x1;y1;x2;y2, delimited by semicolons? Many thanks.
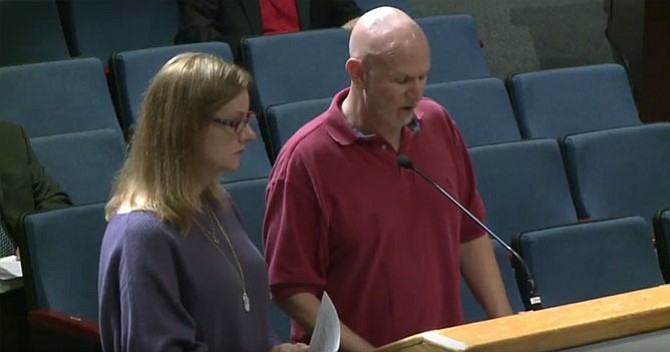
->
349;6;428;61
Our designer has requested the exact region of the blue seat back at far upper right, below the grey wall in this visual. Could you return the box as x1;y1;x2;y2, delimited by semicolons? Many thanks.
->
510;64;641;138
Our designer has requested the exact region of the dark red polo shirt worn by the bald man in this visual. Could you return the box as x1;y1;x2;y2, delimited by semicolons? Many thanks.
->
263;90;484;346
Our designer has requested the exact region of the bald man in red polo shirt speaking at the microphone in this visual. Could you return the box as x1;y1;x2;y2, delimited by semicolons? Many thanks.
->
264;7;512;351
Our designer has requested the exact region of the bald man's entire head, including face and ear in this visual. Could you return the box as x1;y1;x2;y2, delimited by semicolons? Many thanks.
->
342;7;430;140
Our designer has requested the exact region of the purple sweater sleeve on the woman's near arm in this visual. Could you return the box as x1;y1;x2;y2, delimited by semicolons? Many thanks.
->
110;221;208;352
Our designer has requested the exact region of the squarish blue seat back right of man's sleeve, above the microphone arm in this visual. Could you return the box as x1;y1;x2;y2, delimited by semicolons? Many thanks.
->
469;139;577;243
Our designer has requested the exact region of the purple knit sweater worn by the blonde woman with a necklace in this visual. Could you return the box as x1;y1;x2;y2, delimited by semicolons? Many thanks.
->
98;209;275;352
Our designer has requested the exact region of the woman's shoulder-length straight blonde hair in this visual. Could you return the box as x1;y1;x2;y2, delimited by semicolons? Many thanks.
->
105;53;251;234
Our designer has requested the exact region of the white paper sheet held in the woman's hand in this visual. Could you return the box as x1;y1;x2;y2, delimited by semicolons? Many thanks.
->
309;292;340;352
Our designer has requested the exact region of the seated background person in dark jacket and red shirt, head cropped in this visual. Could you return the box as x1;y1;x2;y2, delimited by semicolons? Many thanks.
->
174;0;361;62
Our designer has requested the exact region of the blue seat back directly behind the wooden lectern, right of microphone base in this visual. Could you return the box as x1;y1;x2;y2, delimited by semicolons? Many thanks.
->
515;217;663;308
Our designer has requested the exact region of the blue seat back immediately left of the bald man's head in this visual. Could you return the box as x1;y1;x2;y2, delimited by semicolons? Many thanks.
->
242;28;349;112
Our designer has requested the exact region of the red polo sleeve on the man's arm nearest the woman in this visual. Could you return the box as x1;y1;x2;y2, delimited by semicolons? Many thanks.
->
263;151;328;300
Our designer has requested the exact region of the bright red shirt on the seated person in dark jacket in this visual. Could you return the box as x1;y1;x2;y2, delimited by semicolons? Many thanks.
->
259;0;300;34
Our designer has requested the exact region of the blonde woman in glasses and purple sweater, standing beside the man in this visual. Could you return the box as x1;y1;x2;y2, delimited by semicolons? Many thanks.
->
99;53;307;352
